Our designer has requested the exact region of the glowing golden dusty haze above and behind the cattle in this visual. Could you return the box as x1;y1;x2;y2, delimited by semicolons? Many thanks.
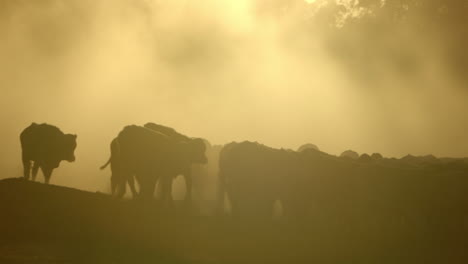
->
0;0;468;190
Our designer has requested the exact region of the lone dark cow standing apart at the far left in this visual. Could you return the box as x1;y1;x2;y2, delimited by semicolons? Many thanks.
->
20;123;77;184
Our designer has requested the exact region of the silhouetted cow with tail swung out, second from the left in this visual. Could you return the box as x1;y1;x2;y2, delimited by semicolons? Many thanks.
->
110;125;206;200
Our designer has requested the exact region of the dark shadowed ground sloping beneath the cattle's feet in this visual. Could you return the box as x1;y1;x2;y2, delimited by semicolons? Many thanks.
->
0;179;468;264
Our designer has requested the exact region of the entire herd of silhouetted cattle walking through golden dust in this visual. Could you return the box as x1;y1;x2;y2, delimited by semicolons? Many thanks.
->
20;123;468;221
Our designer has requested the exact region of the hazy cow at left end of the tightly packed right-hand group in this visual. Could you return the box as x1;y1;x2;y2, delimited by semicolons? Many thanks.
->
218;141;300;219
